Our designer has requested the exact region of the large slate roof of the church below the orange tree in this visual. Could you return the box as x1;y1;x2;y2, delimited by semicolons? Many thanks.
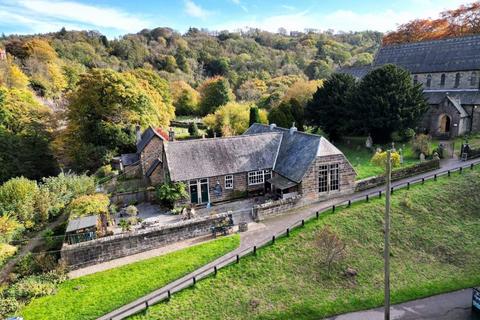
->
373;35;480;73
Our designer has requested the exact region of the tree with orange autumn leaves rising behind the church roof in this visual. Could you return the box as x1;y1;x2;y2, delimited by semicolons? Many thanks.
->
383;1;480;45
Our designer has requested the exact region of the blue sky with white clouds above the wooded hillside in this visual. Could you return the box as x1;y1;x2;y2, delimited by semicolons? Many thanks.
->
0;0;473;38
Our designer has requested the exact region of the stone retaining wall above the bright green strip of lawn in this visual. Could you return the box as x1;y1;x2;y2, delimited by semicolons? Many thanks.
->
61;212;229;269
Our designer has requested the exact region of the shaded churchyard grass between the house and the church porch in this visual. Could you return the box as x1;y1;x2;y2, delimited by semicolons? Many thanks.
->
336;137;420;180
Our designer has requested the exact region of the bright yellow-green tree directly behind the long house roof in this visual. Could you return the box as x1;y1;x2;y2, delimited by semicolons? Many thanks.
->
203;102;267;136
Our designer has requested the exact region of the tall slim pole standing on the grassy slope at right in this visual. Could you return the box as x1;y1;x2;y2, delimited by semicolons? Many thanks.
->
383;150;392;320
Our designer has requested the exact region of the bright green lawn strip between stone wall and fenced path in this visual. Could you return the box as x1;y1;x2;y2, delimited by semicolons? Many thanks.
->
21;235;240;320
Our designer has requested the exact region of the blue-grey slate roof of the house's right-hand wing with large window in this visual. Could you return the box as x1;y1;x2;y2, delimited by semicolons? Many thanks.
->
244;123;343;183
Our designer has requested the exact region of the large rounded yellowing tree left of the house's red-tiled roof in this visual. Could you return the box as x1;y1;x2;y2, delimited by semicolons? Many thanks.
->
61;69;174;171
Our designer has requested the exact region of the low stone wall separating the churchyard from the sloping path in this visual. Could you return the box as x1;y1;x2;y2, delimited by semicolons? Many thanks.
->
355;160;440;191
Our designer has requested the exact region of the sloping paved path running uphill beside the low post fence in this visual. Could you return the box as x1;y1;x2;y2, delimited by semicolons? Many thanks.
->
98;159;480;320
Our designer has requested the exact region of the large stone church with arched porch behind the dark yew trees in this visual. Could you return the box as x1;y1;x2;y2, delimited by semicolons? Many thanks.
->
339;35;480;138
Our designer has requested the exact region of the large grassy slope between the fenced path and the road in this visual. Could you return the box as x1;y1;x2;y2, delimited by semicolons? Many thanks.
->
133;167;480;320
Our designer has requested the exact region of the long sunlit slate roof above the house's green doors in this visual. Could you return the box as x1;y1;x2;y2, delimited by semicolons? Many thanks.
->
165;132;282;181
